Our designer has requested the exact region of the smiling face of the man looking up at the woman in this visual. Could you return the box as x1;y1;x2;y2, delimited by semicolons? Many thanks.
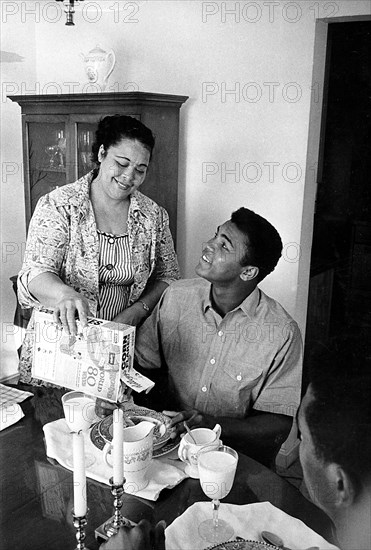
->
196;220;253;284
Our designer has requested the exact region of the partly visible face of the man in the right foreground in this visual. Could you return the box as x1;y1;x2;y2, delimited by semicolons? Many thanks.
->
298;385;336;517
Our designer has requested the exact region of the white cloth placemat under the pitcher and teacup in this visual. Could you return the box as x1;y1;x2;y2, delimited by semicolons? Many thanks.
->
44;418;188;500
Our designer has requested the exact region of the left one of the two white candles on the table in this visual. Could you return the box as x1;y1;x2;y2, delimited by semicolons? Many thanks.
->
72;432;87;517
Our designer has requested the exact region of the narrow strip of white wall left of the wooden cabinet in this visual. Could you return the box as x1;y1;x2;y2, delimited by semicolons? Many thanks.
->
0;9;36;379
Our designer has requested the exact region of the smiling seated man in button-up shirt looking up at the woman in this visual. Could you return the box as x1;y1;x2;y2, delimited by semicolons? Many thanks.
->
127;208;302;465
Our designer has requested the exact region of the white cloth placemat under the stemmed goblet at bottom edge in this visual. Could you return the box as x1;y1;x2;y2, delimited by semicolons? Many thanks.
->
165;502;338;550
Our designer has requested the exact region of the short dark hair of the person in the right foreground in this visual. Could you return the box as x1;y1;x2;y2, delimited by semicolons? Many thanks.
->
305;338;371;494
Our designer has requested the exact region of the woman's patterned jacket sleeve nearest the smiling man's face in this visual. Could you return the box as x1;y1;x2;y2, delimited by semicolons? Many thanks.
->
155;207;180;284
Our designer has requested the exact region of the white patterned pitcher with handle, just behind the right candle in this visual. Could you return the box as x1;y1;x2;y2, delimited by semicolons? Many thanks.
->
103;421;155;493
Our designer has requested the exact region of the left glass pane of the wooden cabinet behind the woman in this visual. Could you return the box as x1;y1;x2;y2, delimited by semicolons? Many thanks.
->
28;122;66;216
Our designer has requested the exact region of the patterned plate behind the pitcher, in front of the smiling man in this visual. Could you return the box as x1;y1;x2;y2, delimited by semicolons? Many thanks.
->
98;407;170;451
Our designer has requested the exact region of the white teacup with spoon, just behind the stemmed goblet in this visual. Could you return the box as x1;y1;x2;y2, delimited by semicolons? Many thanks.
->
178;424;222;479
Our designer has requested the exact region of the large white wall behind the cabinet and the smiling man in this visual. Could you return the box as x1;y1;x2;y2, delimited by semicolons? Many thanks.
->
1;0;370;380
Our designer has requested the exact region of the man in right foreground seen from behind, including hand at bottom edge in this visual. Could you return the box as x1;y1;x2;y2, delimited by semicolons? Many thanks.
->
102;339;371;550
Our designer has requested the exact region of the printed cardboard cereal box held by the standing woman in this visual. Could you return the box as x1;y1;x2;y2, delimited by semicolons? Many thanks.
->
32;309;136;402
